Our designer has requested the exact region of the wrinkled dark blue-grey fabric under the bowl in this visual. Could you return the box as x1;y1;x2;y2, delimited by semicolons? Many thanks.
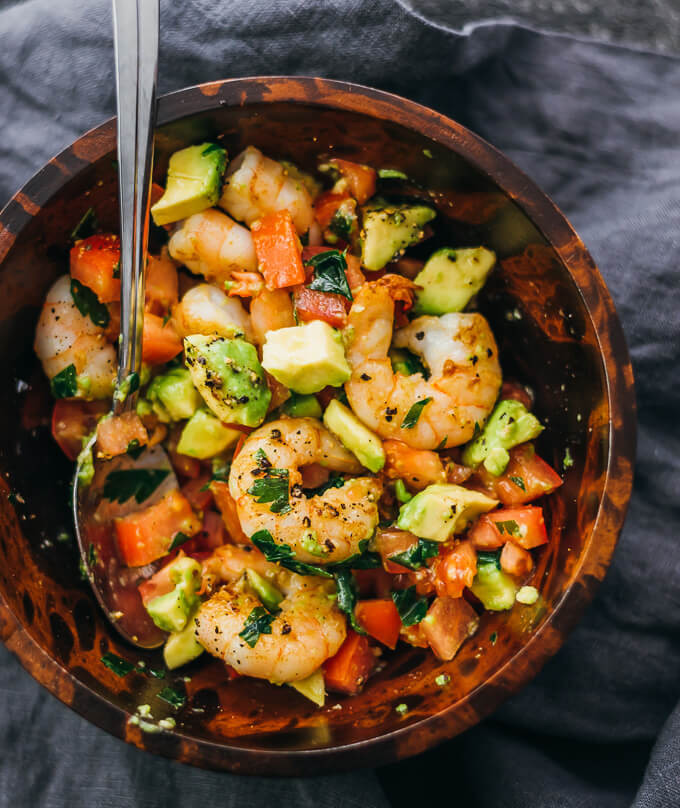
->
0;0;680;808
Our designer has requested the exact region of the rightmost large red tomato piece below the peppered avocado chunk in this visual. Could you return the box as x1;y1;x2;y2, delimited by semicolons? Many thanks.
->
472;443;562;505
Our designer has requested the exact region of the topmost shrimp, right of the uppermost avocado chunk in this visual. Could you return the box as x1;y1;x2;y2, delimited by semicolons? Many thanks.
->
218;146;314;233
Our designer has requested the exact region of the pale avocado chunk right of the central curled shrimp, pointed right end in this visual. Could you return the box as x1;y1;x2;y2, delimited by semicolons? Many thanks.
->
397;484;498;541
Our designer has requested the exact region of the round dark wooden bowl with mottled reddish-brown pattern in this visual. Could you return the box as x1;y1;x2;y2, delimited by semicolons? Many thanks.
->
0;78;635;775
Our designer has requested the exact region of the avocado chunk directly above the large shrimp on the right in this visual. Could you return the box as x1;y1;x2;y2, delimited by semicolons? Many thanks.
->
413;247;496;315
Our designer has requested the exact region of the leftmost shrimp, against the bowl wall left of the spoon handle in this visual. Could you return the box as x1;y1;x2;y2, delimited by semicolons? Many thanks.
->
34;275;116;399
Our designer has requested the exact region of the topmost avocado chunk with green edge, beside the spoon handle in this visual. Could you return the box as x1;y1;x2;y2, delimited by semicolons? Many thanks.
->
151;143;227;226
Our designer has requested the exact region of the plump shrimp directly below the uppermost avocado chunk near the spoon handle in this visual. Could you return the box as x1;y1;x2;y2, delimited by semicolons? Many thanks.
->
168;208;257;284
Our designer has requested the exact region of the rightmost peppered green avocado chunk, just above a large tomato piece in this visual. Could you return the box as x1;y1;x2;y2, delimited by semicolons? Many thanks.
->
462;399;543;476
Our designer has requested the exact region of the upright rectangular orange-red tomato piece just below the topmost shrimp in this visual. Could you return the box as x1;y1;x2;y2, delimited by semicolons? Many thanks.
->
251;210;305;289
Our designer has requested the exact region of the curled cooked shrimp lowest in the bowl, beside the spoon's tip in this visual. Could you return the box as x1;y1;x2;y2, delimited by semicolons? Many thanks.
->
194;545;347;684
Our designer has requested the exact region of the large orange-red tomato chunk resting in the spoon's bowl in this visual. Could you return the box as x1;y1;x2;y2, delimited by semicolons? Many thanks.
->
115;489;201;567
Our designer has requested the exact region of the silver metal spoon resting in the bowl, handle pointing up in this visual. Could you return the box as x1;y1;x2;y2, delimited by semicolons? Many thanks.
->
73;0;166;648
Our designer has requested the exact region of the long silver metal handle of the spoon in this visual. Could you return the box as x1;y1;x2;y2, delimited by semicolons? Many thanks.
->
113;0;159;413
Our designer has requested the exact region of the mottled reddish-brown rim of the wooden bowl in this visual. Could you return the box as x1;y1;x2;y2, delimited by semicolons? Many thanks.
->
0;76;636;775
